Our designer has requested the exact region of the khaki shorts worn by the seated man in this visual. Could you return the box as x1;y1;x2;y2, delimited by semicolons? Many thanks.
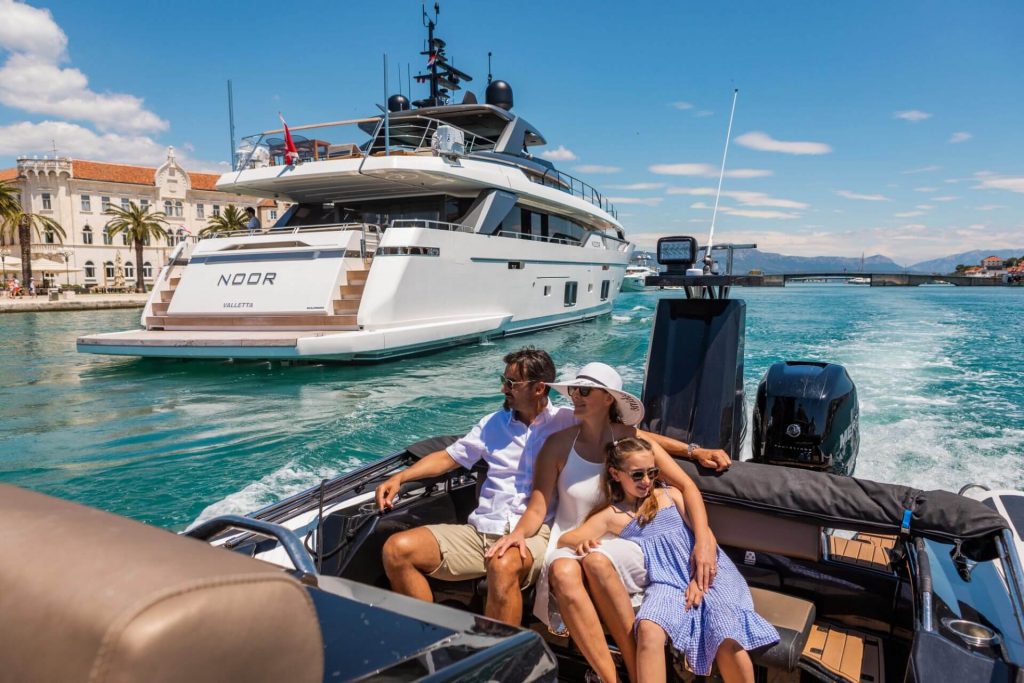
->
424;524;551;588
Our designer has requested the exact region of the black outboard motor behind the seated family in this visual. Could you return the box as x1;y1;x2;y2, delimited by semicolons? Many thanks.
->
751;360;860;475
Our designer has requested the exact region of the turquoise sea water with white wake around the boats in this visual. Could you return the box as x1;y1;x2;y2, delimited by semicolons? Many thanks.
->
0;285;1024;529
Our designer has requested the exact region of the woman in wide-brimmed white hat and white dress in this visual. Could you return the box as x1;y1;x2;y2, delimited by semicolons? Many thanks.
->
486;362;728;682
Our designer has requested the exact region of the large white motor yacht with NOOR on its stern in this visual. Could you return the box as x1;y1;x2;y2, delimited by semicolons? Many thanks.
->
78;13;633;361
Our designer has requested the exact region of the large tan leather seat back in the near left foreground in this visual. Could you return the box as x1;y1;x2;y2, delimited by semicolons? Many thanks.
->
0;484;324;683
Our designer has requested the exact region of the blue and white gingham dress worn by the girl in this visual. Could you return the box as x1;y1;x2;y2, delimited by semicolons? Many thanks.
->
620;505;778;676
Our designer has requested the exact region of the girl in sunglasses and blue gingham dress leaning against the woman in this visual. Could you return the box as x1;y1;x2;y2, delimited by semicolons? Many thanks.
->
558;437;778;683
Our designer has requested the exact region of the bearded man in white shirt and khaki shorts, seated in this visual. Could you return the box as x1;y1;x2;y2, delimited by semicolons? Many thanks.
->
377;347;575;626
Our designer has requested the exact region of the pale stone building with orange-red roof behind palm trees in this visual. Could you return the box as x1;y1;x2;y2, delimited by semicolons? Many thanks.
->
0;147;283;288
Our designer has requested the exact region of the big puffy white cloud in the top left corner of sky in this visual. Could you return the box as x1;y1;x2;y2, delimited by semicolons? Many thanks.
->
0;0;169;134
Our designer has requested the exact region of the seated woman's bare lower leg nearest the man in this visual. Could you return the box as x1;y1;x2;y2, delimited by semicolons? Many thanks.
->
548;557;615;683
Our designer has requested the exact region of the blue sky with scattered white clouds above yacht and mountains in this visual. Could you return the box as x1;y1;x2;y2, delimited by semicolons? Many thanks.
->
0;0;1024;264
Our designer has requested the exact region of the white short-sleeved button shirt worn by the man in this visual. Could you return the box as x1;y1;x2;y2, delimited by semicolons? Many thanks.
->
447;401;577;535
